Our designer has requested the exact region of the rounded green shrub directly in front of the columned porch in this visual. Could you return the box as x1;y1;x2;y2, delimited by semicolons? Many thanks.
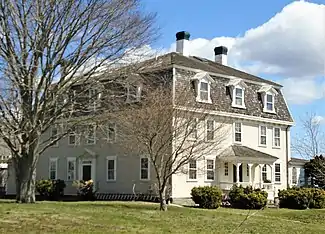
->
229;185;268;209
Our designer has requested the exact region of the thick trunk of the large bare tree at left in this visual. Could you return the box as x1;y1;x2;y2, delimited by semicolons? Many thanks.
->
15;156;36;203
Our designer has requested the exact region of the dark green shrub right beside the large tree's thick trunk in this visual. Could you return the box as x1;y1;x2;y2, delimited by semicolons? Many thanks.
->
36;180;66;201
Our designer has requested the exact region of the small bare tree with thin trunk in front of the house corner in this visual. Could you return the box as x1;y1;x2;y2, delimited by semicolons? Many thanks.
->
111;74;229;211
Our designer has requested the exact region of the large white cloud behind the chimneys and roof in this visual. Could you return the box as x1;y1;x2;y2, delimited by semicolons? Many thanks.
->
165;1;325;104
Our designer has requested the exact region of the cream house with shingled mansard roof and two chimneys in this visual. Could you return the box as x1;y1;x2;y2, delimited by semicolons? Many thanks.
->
8;31;302;202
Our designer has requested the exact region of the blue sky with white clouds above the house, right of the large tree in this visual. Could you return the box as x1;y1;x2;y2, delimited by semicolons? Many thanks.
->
145;0;325;150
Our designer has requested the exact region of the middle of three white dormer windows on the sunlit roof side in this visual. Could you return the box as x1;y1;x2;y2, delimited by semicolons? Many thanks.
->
227;79;247;108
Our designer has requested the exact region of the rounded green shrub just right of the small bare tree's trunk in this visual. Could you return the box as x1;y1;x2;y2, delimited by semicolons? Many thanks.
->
191;186;222;209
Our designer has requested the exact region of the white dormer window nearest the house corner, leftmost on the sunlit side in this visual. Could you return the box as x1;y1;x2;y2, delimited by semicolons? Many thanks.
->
192;72;214;103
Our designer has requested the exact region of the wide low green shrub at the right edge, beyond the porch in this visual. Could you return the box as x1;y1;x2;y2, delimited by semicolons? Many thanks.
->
278;187;325;209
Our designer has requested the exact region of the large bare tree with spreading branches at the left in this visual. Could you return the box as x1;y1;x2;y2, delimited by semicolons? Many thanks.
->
0;0;155;203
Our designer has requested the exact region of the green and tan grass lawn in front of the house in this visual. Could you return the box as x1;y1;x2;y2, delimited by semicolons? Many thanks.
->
0;201;325;234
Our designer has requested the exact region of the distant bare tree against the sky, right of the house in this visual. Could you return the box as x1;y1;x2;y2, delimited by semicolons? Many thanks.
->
292;113;325;159
